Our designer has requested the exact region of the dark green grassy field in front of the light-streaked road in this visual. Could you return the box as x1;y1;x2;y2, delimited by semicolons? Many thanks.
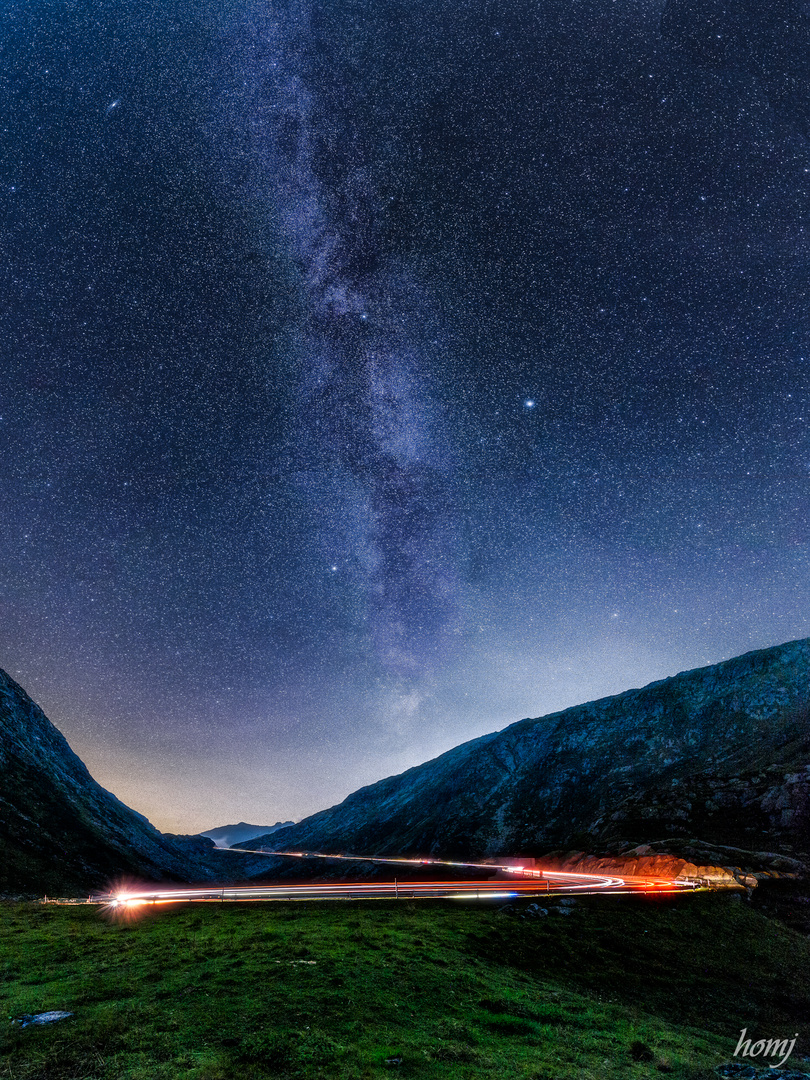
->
0;894;810;1080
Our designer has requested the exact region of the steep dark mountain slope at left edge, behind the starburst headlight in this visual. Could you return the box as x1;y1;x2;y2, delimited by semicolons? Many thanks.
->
0;671;222;895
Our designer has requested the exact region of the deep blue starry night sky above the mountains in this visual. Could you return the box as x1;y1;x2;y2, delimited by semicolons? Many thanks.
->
0;0;810;832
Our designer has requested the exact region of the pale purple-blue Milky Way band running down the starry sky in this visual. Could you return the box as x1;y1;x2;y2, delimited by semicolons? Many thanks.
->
216;4;455;677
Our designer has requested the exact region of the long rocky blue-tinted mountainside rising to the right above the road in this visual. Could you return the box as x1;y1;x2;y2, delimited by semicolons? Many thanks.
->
258;639;810;858
